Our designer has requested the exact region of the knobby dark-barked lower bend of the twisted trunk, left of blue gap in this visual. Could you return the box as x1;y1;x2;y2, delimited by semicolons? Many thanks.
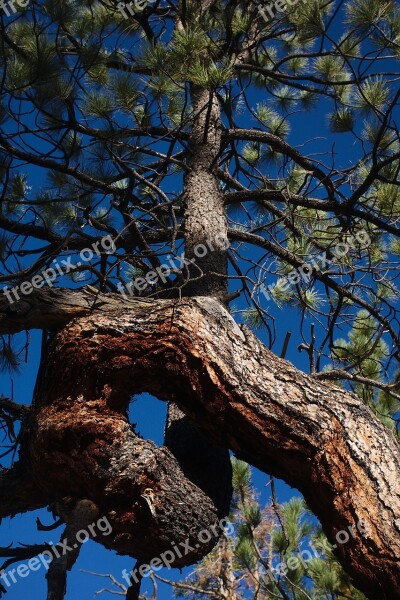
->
29;380;228;567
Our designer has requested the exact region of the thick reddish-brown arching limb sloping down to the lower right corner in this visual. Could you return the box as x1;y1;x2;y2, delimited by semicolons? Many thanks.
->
4;290;400;598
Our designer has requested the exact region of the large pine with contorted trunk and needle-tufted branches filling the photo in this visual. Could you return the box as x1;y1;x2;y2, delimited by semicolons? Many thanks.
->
0;0;400;600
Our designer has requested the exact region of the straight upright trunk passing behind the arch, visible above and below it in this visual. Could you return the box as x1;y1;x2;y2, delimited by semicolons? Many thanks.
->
165;78;232;517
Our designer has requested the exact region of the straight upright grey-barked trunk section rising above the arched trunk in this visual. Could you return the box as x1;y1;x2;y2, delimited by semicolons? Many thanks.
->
184;86;229;302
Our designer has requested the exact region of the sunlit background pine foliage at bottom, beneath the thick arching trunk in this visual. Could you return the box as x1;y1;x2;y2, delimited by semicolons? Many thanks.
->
169;459;365;600
